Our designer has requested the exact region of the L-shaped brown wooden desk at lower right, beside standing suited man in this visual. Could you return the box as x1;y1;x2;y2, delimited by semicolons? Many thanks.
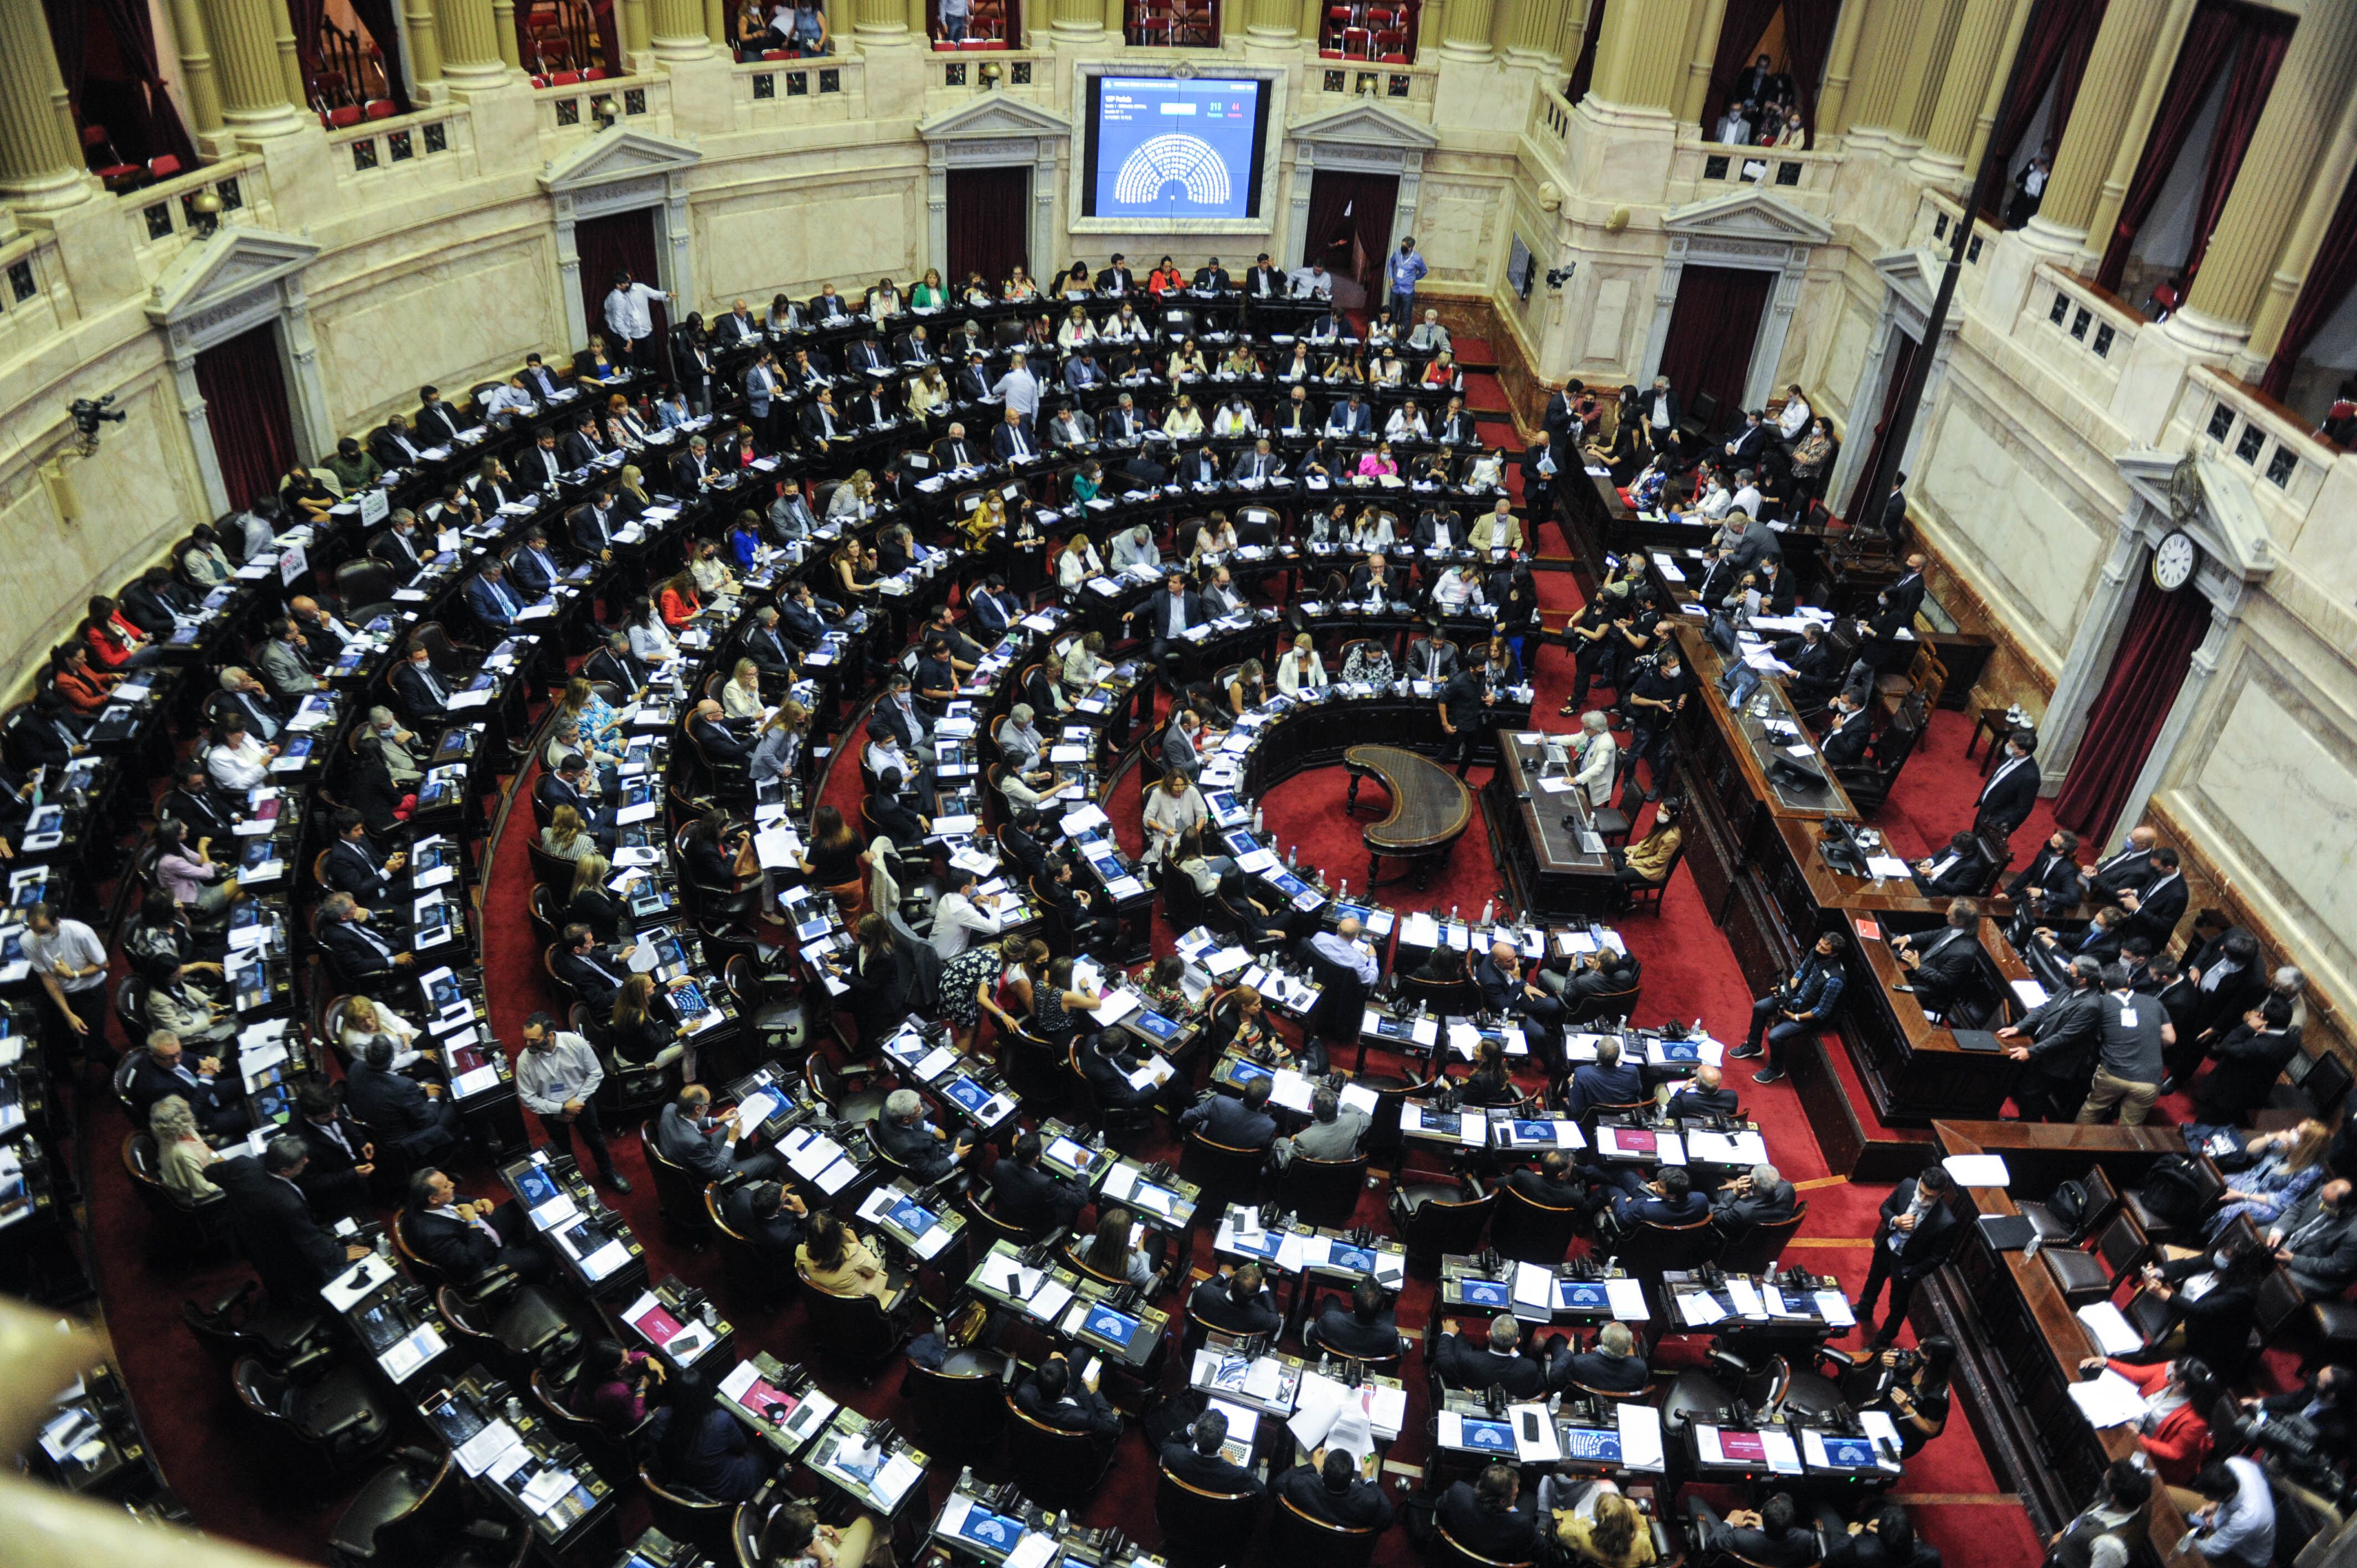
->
1916;1120;2185;1561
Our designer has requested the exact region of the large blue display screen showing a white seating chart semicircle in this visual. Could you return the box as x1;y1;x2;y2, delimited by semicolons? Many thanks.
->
1084;75;1268;221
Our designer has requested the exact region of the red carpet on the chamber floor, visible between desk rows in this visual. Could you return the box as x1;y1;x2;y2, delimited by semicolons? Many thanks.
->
69;464;2039;1568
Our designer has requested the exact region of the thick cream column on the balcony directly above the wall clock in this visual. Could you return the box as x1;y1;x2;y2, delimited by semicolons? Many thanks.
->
2164;5;2357;354
